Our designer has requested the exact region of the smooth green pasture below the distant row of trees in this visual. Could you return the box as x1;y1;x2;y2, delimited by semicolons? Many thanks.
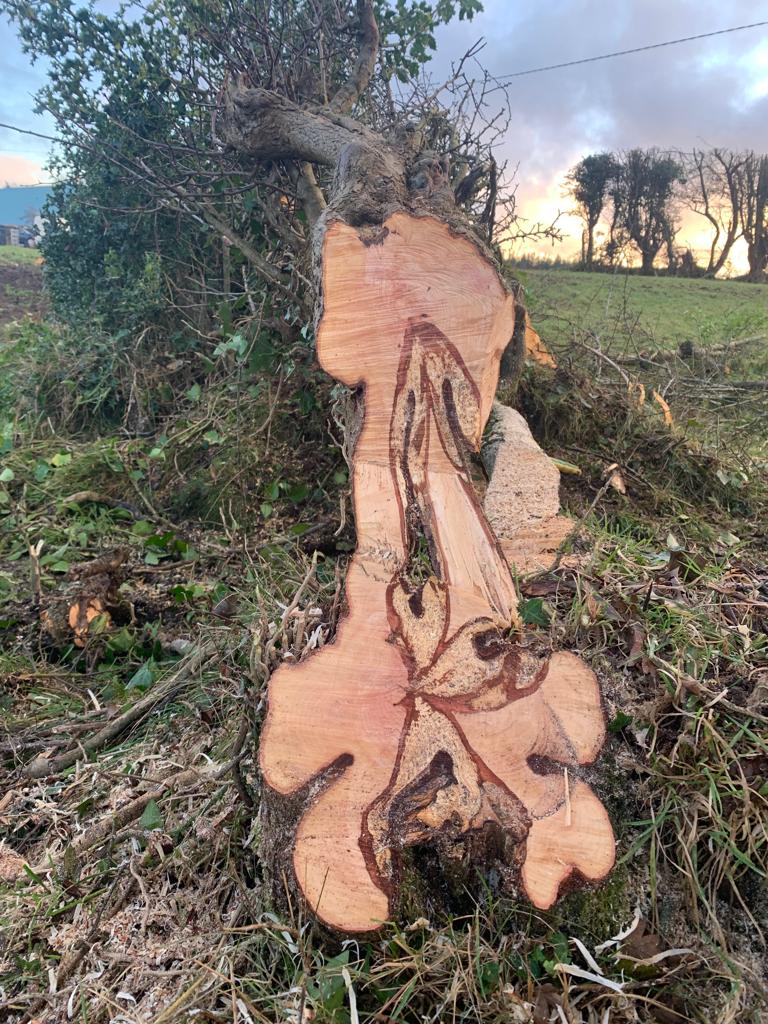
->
515;269;768;350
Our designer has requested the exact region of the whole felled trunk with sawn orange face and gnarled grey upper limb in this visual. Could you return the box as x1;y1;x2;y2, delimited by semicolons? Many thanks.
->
216;16;613;933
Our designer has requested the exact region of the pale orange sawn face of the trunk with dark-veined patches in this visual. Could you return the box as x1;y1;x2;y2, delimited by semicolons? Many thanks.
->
260;213;614;932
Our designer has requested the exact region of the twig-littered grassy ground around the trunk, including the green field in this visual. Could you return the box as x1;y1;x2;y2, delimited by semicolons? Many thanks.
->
0;262;768;1024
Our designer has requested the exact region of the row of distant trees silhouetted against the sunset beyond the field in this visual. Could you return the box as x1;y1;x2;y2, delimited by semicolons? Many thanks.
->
566;147;768;282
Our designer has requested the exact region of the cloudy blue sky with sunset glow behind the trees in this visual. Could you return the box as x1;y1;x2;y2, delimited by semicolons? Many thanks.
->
0;0;768;262
